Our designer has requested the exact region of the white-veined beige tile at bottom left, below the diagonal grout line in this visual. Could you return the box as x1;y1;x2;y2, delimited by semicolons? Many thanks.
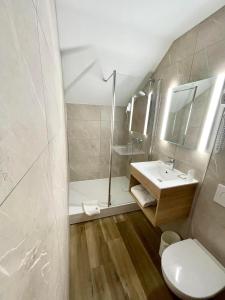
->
0;149;68;300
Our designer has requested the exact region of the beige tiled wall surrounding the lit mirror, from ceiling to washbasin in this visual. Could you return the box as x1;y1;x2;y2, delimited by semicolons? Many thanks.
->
154;7;225;185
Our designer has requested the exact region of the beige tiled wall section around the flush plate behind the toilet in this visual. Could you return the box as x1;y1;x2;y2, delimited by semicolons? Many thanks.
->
192;123;225;265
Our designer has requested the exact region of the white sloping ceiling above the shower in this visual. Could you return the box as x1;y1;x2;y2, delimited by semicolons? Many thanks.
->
56;0;225;105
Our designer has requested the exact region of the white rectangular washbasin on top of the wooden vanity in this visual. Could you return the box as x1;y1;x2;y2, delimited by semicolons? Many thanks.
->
131;160;198;189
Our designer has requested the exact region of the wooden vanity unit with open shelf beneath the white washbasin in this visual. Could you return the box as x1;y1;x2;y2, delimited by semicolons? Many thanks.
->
129;166;198;226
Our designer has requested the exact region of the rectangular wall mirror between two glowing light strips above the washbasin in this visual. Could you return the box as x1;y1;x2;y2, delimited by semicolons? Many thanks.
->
164;77;216;149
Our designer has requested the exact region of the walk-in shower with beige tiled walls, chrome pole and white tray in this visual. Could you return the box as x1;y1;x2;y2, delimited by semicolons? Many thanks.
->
67;71;157;223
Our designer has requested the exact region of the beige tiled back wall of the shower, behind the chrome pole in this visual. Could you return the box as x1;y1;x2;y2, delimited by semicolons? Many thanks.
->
66;104;128;181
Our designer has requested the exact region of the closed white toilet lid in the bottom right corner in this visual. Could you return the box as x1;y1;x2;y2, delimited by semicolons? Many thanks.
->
162;239;225;298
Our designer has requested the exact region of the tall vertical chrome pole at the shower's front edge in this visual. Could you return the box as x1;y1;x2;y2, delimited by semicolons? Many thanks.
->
103;70;116;207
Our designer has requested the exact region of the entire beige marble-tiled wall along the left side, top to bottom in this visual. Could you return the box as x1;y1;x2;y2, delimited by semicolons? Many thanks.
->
0;0;68;300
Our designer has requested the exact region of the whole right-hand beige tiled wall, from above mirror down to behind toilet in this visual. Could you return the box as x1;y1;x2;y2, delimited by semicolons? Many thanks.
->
154;7;225;260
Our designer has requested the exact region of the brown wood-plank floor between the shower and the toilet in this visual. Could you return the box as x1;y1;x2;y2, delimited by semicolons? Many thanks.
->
70;211;177;300
